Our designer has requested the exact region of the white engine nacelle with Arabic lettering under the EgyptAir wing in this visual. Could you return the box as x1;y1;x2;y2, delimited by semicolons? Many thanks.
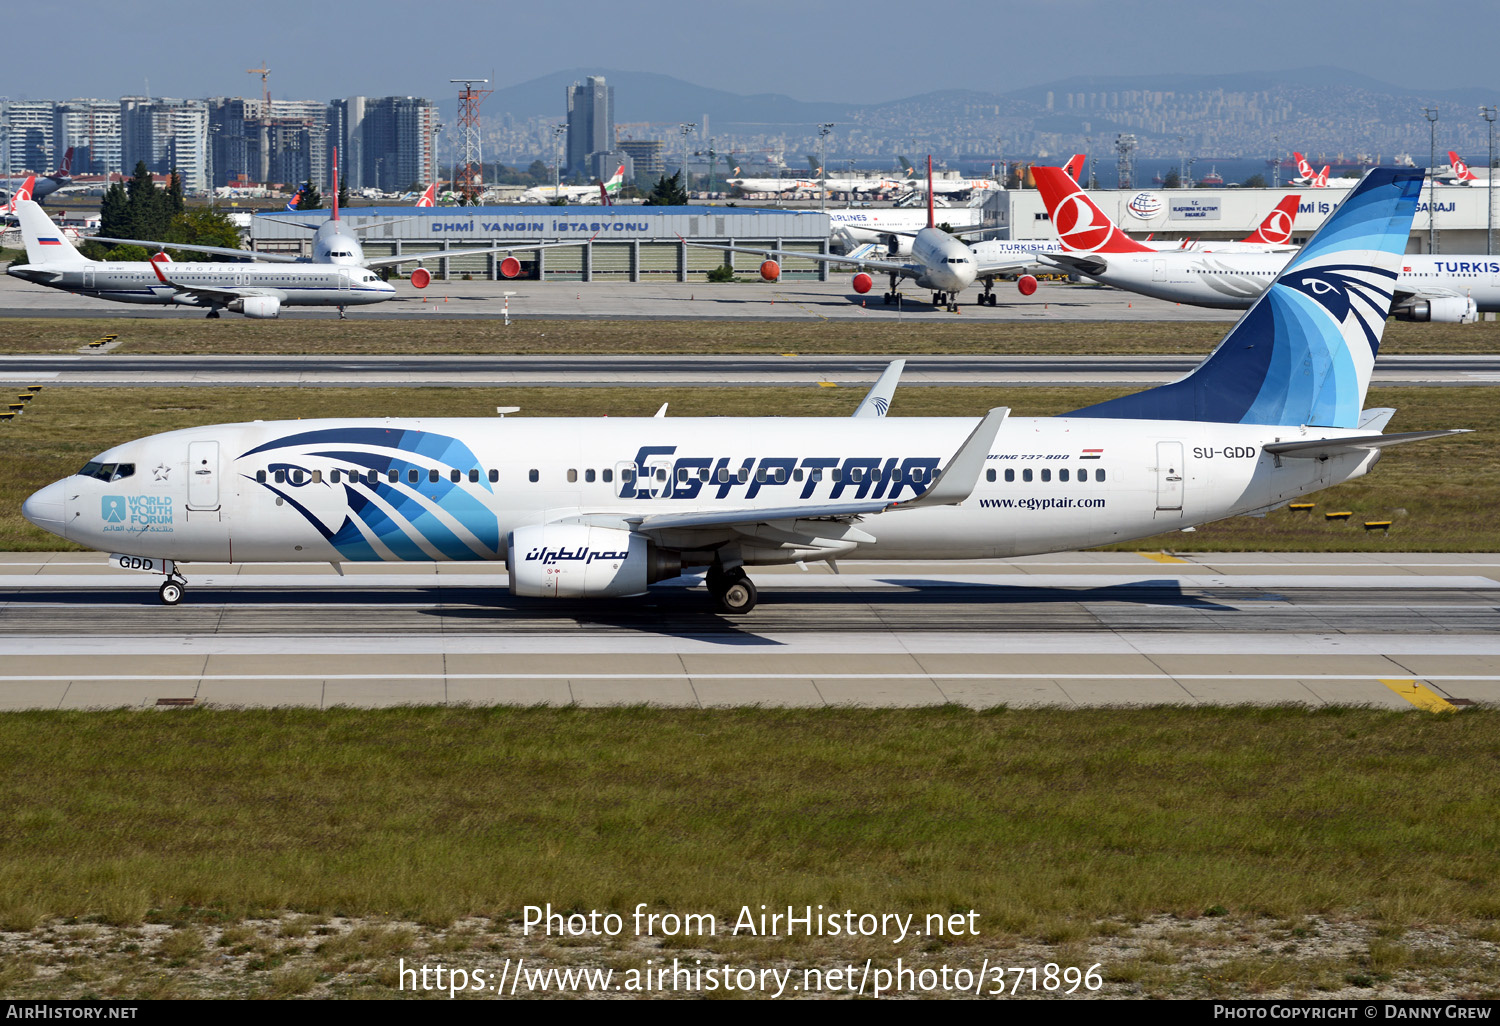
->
506;524;683;599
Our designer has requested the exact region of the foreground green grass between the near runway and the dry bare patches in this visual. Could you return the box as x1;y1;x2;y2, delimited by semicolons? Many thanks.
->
0;707;1500;938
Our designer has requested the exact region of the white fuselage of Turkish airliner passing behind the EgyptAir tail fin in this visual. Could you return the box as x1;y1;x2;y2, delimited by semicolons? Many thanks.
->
1074;252;1500;312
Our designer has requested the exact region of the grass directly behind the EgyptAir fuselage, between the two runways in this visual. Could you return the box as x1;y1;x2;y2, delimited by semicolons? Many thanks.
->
0;381;1500;552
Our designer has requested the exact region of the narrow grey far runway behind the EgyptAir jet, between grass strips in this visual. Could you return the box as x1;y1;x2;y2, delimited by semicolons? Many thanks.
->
0;353;1500;389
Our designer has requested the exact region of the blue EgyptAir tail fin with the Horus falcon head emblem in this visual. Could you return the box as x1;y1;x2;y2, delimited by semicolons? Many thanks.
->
1068;168;1424;428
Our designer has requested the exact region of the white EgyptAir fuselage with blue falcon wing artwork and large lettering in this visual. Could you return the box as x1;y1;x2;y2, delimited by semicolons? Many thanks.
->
24;417;1376;566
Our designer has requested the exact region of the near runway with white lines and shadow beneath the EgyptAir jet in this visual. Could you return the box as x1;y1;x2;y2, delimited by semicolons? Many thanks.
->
0;552;1500;711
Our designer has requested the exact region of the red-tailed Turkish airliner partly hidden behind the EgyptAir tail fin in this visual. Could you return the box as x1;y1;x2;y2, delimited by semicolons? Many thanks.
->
1032;168;1500;324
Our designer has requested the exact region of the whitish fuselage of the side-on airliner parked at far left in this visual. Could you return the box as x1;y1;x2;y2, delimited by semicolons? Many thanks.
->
9;261;396;308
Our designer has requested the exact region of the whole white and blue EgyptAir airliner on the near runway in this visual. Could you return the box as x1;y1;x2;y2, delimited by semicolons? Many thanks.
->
21;168;1452;614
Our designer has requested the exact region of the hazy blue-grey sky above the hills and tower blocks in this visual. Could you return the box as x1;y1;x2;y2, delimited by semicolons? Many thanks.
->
0;0;1500;102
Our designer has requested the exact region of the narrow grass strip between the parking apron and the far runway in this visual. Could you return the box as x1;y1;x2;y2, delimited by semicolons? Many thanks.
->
0;315;1500;357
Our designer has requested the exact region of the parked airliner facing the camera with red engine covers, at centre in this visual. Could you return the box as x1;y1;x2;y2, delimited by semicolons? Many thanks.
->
683;158;1035;312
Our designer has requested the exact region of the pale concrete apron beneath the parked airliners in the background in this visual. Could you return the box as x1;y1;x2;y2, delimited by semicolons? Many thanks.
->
0;273;1239;321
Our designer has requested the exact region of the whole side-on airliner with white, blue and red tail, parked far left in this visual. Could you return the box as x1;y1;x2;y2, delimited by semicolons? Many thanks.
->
6;200;396;318
